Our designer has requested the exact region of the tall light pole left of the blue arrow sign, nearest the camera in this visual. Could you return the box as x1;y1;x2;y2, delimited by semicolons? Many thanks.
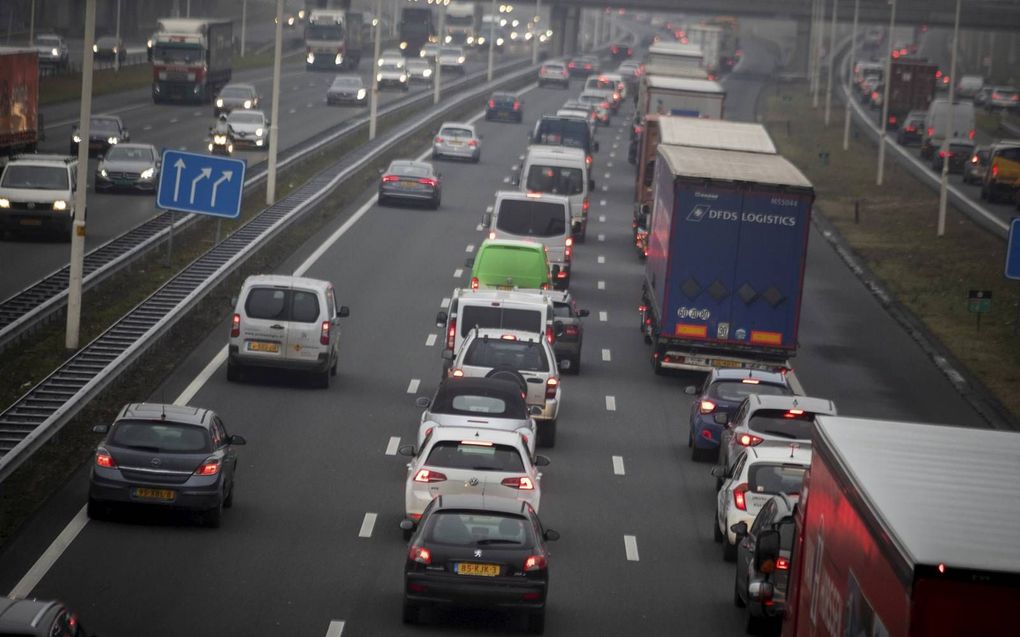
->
64;0;96;350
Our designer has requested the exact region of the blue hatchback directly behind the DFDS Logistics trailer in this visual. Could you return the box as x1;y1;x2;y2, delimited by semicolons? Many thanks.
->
685;368;794;461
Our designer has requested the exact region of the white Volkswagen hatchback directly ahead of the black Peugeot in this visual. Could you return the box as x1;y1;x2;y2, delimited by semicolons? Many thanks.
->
400;427;549;523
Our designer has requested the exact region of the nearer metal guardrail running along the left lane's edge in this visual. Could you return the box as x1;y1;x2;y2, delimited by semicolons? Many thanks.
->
0;61;534;481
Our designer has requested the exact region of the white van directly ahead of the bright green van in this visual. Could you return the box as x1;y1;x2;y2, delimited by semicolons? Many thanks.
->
482;188;573;289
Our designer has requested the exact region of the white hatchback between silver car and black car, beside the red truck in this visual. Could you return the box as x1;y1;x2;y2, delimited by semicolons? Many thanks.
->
712;442;811;562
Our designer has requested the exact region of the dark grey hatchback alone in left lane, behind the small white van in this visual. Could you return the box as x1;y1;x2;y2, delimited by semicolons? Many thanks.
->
87;403;245;528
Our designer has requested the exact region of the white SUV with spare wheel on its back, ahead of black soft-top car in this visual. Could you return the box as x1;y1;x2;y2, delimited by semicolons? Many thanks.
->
444;329;569;446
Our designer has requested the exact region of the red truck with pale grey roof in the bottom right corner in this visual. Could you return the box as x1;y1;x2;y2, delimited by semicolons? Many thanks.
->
782;416;1020;637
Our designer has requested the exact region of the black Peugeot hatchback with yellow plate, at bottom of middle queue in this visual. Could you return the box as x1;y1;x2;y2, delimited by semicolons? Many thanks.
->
401;495;559;634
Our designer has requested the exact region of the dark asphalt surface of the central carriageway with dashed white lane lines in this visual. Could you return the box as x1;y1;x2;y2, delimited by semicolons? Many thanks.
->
0;31;981;637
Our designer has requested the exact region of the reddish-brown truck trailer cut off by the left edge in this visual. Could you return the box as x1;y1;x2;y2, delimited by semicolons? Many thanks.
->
0;47;42;155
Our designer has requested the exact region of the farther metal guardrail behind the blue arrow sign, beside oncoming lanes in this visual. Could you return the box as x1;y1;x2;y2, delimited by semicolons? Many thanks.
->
0;54;530;352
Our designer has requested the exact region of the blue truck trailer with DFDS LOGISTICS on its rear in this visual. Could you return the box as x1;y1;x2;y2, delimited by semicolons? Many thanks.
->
641;145;814;373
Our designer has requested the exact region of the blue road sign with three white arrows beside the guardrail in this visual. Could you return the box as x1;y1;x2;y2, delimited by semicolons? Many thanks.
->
156;151;246;219
